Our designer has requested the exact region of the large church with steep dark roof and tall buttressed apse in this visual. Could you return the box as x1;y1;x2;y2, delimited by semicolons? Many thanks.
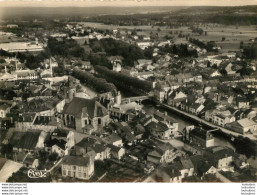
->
63;97;109;134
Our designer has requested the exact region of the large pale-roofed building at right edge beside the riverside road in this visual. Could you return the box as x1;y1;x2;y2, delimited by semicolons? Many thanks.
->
226;118;257;134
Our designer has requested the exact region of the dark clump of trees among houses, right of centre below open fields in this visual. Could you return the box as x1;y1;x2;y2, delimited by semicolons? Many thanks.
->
160;44;198;58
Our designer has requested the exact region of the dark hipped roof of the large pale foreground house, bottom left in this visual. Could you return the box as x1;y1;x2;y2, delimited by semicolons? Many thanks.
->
62;155;90;167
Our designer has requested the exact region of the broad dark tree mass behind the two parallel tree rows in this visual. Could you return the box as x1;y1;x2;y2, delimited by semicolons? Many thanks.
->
89;38;145;66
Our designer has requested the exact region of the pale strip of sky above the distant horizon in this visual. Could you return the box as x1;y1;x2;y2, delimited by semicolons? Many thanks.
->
0;0;257;7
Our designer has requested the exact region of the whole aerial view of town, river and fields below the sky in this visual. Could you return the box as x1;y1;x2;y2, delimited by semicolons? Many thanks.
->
0;5;257;183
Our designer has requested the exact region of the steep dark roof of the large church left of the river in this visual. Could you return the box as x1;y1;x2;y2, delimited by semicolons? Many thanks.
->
63;97;108;119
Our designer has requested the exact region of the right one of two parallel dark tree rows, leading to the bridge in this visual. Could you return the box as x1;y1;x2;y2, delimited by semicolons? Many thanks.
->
95;66;152;93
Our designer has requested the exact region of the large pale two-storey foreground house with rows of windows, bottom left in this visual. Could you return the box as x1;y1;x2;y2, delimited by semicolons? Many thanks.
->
62;155;94;180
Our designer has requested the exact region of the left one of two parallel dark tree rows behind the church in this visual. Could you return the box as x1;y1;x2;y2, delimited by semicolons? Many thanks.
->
72;68;117;93
